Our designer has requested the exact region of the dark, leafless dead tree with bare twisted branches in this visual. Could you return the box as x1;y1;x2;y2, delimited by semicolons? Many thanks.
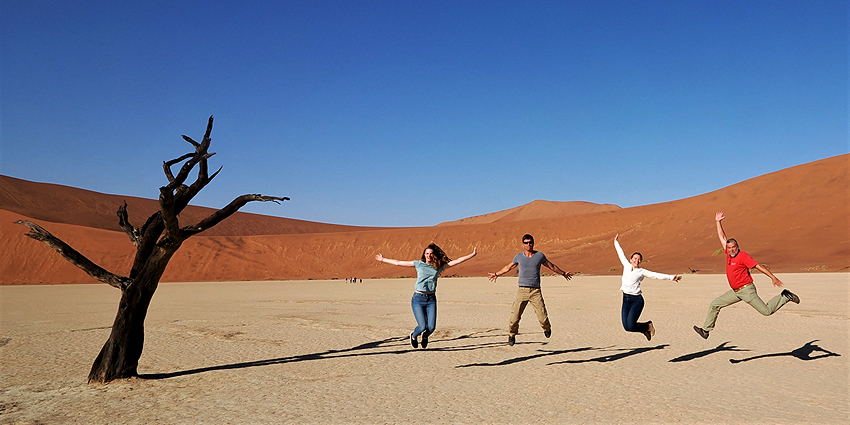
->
16;117;289;383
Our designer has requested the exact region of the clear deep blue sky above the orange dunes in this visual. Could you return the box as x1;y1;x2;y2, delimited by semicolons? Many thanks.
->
0;0;850;226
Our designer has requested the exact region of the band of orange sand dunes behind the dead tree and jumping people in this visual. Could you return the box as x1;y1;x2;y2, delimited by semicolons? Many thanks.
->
0;154;850;284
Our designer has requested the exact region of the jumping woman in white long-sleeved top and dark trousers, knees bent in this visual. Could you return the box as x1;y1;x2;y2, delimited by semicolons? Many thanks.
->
614;233;682;341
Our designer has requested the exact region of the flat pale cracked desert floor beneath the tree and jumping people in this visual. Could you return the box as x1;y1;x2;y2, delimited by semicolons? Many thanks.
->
0;273;850;424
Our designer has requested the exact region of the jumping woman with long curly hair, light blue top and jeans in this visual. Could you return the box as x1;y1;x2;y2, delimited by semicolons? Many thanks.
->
375;244;478;348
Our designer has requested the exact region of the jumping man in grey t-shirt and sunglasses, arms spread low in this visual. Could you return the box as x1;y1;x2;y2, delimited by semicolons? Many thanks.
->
488;234;573;345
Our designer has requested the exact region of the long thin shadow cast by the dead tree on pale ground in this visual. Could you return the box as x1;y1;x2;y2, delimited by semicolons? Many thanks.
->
138;331;505;379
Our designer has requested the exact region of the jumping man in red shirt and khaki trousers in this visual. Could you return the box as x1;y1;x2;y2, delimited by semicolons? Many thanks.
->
694;211;800;339
